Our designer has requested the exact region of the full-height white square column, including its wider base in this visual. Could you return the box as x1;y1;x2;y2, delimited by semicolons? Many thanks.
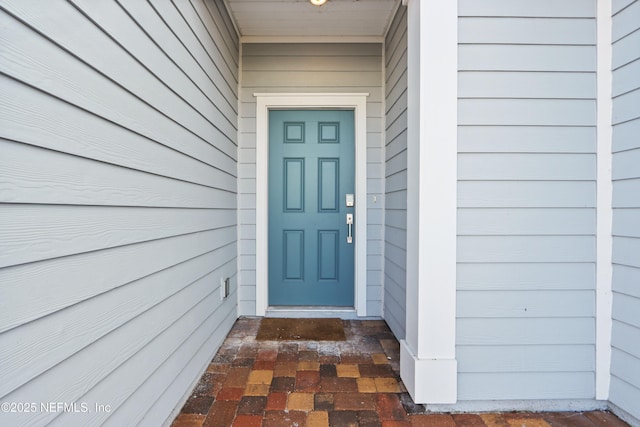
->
400;0;458;404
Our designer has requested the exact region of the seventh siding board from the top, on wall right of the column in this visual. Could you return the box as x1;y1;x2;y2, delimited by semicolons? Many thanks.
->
458;153;596;181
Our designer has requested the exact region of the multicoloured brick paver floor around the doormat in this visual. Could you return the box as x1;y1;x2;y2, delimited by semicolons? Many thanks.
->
172;318;627;427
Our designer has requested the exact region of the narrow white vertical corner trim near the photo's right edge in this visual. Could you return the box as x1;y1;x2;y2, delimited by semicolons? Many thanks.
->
596;0;613;400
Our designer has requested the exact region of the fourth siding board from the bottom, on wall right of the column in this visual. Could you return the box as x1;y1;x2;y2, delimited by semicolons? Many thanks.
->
457;290;595;319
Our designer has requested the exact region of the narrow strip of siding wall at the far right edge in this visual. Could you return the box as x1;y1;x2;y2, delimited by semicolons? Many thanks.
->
609;0;640;425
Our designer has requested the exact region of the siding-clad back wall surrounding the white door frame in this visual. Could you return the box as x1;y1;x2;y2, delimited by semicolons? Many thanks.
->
238;43;384;316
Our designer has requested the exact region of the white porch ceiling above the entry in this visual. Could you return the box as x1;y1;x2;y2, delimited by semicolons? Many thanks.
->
225;0;400;41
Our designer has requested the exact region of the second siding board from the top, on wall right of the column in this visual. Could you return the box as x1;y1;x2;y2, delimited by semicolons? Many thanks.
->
458;17;596;45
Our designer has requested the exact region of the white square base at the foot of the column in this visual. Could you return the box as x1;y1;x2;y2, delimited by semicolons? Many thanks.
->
400;340;458;404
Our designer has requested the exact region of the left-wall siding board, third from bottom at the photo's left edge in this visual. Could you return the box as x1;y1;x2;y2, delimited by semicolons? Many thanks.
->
0;228;236;331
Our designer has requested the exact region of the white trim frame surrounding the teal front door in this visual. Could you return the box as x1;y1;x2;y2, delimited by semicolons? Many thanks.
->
253;93;369;317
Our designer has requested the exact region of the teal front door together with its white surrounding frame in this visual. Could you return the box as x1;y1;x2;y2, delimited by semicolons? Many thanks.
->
255;94;368;316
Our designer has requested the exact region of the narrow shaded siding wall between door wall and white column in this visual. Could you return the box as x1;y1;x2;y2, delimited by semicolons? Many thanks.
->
384;7;407;339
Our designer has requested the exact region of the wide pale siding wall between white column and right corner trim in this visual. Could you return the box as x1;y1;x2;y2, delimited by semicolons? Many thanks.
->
456;0;596;406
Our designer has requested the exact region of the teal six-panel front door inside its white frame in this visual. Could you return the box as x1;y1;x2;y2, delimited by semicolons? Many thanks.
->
269;110;357;307
